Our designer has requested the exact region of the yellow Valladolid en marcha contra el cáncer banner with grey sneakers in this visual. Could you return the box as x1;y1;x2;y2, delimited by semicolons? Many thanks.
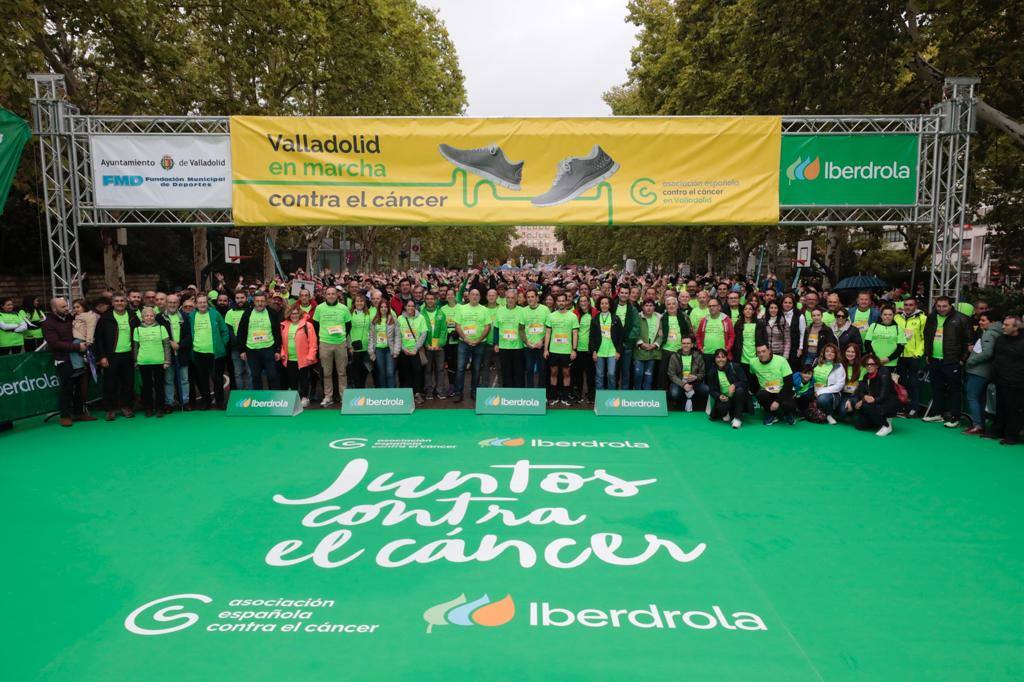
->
231;116;781;225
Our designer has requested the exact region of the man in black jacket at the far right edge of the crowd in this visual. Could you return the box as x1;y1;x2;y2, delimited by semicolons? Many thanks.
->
987;315;1024;445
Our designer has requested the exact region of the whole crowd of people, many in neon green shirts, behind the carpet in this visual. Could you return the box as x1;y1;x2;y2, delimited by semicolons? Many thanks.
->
0;267;1024;444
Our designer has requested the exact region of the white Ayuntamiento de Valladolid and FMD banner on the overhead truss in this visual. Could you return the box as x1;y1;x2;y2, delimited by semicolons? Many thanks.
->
90;135;231;208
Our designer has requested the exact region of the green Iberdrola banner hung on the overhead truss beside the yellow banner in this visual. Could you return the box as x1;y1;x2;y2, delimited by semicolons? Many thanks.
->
778;134;920;206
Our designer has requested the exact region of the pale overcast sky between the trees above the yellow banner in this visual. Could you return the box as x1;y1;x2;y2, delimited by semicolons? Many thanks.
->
420;0;636;116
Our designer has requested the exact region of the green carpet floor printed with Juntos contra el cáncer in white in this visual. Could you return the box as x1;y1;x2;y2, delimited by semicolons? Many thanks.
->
0;410;1024;681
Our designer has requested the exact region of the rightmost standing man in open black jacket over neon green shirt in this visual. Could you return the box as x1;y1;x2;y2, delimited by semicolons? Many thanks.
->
922;296;971;429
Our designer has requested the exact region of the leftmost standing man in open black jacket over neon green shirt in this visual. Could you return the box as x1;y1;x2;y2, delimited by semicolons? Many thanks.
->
93;294;139;422
